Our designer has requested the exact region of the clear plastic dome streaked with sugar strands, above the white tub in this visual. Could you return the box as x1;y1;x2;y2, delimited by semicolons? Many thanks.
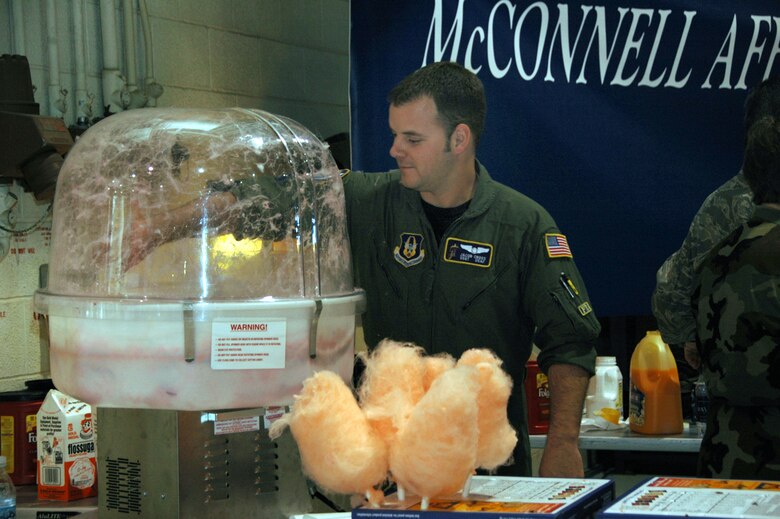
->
47;109;352;300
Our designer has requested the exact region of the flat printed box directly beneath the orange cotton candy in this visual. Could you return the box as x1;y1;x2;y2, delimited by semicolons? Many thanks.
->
352;476;615;519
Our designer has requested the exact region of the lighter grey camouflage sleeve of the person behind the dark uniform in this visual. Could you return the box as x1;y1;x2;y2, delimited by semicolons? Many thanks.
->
652;172;754;344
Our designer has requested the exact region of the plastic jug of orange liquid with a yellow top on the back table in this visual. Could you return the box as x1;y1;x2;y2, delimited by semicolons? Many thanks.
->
628;331;683;434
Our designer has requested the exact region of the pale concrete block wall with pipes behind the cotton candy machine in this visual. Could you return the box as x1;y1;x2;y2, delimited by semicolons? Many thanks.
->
0;0;349;392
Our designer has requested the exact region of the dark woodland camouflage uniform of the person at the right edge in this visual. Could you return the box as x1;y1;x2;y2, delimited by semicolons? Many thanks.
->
692;205;780;480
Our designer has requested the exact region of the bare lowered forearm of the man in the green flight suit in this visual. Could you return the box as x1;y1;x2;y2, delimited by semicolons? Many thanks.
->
539;364;589;478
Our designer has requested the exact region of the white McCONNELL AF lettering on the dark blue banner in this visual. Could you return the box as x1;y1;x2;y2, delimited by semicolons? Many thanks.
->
422;0;780;90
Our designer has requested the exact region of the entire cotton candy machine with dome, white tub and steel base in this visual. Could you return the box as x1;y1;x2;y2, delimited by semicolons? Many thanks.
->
35;108;364;519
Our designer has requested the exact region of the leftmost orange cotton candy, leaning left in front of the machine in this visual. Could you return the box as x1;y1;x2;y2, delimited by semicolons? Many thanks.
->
280;371;388;494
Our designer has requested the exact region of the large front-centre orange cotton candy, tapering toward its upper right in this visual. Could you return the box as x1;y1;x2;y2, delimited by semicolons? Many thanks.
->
390;366;478;498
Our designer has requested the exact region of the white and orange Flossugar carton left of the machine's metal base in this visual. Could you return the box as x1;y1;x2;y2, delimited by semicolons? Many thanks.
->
38;389;97;501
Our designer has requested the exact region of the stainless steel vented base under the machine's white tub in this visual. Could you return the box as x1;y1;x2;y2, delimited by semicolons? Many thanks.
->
97;407;312;519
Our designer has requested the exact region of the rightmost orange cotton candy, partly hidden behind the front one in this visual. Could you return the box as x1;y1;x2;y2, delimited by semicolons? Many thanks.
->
458;349;517;470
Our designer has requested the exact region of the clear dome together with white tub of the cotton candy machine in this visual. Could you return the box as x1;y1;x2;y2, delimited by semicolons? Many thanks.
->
36;108;363;409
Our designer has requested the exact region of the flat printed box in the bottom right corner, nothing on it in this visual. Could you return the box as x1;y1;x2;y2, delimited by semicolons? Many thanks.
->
598;477;780;519
